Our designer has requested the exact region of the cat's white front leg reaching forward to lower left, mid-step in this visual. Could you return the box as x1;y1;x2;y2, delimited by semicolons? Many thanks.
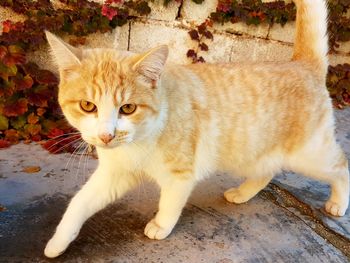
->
44;166;133;258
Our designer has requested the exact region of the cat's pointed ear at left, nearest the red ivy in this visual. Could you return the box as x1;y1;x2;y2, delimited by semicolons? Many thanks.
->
45;31;82;72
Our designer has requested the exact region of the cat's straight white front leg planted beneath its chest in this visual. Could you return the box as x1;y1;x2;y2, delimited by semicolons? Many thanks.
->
145;176;195;239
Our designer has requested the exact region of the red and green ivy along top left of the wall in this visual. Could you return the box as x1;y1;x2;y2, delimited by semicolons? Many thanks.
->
0;0;150;51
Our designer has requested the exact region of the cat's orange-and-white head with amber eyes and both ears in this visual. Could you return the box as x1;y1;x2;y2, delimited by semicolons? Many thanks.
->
46;32;168;147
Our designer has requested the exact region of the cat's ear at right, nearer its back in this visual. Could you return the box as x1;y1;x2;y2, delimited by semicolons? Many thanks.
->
133;45;169;82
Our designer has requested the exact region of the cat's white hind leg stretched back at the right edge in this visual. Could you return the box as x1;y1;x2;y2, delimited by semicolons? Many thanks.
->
290;135;349;216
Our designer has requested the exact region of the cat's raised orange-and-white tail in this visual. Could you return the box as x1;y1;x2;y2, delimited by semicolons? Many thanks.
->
293;0;328;76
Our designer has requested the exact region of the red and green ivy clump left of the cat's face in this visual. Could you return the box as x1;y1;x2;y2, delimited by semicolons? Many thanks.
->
0;45;72;148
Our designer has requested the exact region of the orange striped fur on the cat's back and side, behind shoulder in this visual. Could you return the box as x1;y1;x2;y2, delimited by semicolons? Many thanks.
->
164;61;332;166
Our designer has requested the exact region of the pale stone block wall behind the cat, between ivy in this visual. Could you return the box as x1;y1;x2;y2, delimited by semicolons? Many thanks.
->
0;0;350;74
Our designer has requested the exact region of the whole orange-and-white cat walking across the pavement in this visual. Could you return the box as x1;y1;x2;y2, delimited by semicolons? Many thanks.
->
45;0;349;258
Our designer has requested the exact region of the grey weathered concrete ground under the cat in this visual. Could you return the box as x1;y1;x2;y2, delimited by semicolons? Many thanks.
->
0;109;350;263
